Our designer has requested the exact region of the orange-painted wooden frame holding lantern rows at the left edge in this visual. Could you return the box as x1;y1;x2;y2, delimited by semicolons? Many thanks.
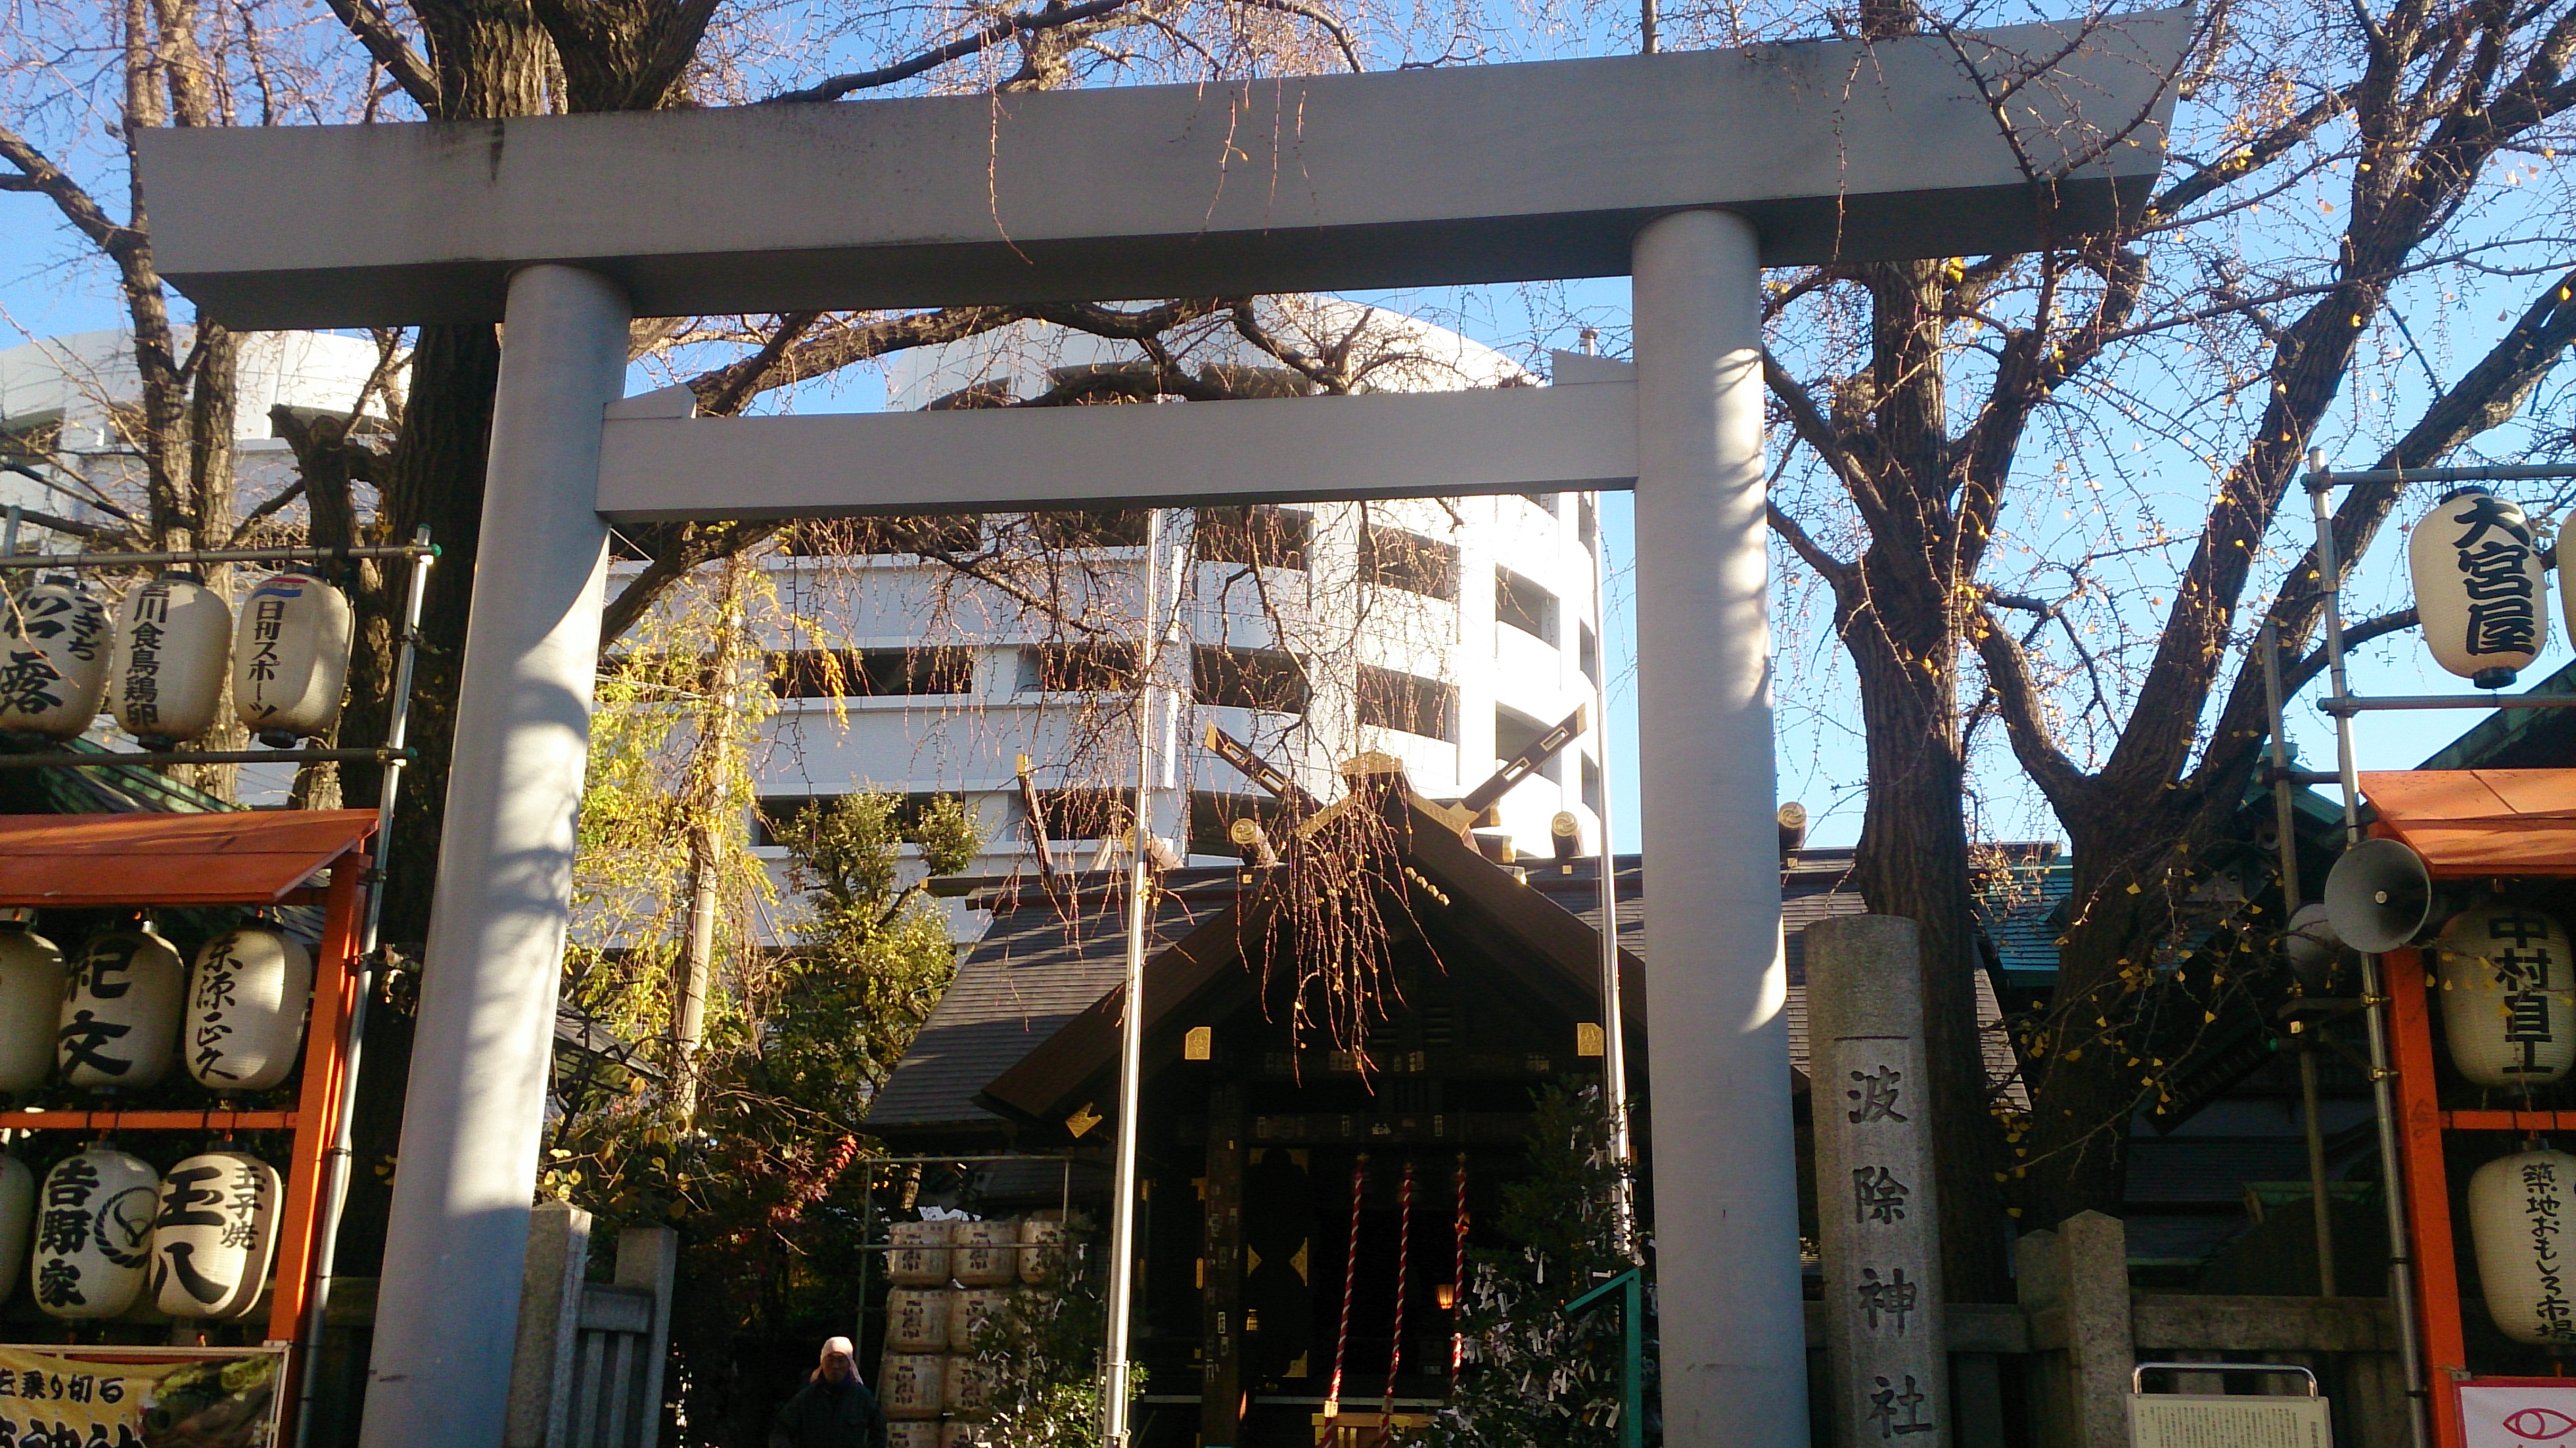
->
0;811;373;1432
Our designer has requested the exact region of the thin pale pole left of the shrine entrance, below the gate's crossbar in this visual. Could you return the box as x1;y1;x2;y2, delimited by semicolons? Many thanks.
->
1100;508;1177;1448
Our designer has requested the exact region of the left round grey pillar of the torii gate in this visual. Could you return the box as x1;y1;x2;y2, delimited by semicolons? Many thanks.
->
361;263;631;1448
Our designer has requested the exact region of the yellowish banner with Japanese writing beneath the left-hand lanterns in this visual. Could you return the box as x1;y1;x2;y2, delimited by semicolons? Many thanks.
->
0;1345;286;1448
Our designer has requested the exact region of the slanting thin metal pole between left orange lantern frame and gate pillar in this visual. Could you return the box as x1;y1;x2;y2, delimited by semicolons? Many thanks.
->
296;523;438;1448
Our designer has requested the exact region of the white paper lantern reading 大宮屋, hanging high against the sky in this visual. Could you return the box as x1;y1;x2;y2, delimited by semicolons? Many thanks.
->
2406;487;2550;688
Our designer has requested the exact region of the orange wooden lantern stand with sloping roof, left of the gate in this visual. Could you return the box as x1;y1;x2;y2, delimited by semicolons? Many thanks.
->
0;809;376;1443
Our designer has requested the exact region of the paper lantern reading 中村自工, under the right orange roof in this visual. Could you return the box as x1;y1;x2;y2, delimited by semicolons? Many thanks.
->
2434;905;2576;1087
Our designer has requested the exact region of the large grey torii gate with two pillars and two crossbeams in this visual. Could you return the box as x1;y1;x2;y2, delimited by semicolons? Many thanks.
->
139;11;2192;1448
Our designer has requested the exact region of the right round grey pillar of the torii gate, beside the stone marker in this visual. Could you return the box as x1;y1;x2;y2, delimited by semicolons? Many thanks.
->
1630;212;1808;1448
